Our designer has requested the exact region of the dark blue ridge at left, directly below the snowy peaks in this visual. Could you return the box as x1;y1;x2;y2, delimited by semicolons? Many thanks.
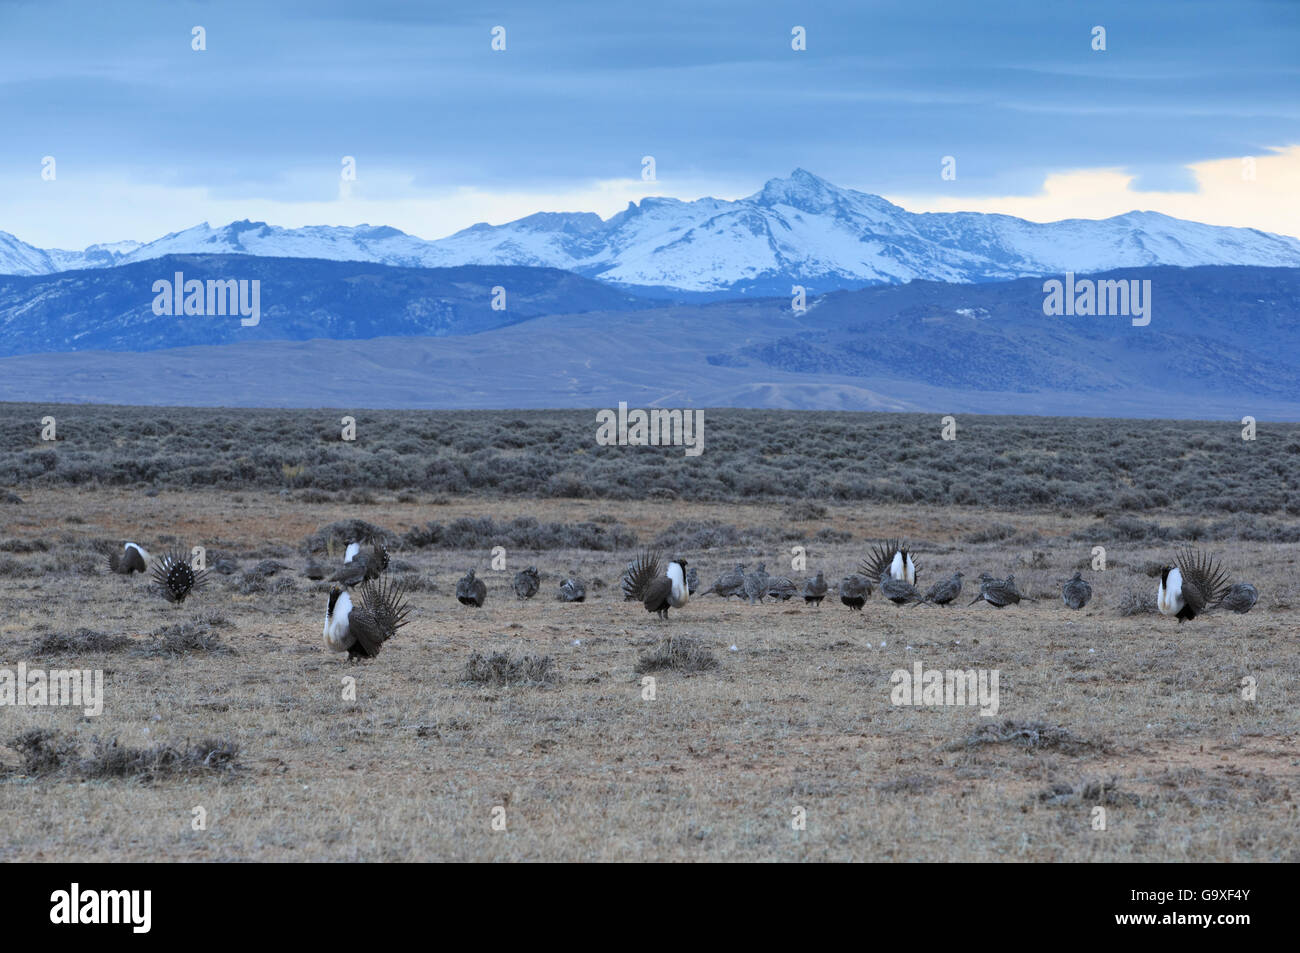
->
0;255;660;356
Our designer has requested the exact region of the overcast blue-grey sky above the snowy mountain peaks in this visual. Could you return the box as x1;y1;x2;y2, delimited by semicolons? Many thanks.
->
0;0;1300;248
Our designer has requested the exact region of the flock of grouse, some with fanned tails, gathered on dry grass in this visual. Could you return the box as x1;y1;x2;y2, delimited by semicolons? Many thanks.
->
108;540;1260;660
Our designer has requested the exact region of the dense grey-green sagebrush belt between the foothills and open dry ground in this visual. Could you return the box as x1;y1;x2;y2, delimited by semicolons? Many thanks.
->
0;404;1300;520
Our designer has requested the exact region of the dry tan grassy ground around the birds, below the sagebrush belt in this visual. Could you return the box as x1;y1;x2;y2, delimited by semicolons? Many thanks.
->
0;489;1300;862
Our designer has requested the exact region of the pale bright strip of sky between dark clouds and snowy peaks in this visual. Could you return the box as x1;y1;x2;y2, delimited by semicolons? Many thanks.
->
12;146;1300;248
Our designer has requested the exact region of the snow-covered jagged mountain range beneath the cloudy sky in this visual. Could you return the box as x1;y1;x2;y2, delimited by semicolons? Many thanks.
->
0;169;1300;291
